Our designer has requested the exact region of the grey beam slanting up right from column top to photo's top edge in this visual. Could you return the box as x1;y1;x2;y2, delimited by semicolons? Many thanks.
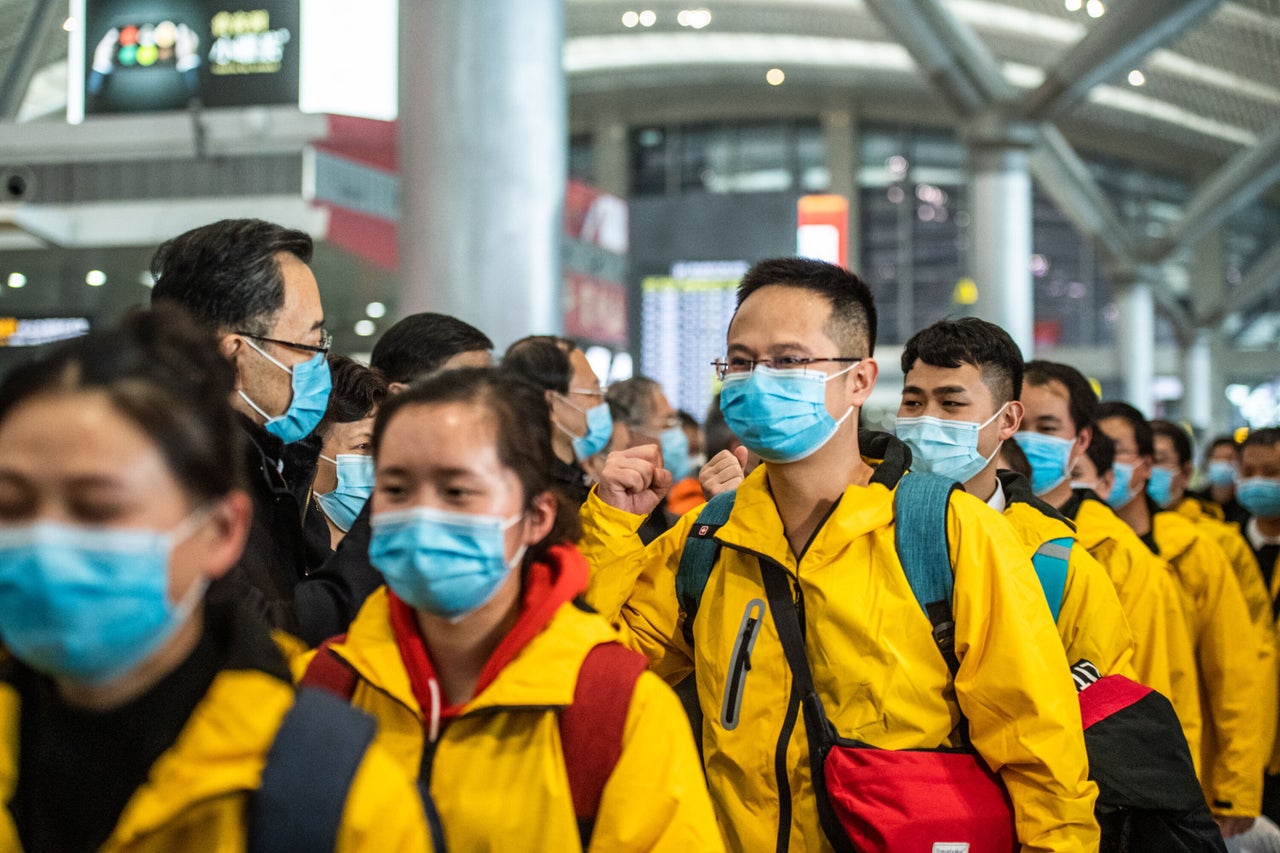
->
1021;0;1220;120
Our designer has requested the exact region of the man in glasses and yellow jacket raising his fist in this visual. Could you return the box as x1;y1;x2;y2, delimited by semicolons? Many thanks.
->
581;259;1098;852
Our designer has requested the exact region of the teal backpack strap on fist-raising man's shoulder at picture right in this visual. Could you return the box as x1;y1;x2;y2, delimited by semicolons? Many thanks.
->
893;471;960;675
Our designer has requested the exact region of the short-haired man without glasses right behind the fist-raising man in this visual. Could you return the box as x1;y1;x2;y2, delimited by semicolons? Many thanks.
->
896;318;1137;678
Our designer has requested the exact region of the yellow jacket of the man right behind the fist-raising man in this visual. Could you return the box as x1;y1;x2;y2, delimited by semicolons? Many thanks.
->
1000;471;1138;680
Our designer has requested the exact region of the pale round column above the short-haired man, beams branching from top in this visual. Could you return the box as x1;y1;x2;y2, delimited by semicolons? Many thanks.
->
966;124;1034;359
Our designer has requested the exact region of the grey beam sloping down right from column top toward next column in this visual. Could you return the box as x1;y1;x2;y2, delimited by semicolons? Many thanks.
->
1030;124;1141;266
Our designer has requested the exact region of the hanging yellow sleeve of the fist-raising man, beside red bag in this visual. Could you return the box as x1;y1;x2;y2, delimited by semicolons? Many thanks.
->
947;493;1098;853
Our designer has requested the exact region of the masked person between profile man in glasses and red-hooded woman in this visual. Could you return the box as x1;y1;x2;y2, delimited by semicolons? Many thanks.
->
312;355;388;549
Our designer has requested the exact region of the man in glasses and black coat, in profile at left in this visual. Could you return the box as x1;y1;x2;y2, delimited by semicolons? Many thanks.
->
151;219;330;633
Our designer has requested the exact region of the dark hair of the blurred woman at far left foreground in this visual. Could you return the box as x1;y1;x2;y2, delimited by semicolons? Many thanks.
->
0;305;244;505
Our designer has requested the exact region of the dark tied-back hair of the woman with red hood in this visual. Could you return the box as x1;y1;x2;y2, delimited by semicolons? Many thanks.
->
374;368;581;558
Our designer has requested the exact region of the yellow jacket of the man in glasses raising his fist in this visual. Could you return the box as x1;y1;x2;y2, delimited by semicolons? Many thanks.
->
582;448;1098;852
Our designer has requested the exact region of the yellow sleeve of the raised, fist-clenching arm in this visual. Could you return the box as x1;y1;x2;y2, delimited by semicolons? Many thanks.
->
579;489;696;684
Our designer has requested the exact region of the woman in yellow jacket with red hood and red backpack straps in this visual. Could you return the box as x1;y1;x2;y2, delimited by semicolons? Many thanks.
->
298;368;722;853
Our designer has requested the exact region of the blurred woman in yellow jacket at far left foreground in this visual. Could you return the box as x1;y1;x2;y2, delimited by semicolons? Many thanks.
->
0;313;430;853
